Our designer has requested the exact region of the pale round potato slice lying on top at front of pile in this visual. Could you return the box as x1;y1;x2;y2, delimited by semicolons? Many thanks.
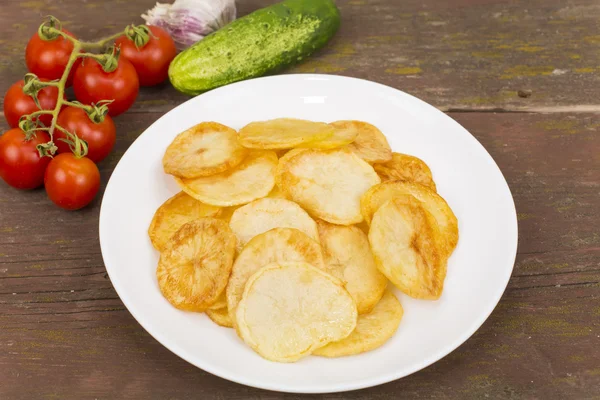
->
236;262;357;362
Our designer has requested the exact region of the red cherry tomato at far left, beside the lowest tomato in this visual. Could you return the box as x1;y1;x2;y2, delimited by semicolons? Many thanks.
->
0;128;51;189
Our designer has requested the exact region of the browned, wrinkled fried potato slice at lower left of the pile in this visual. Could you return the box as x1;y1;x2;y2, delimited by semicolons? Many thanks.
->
156;218;236;311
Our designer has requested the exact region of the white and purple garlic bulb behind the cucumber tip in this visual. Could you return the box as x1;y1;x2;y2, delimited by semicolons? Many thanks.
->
142;0;236;50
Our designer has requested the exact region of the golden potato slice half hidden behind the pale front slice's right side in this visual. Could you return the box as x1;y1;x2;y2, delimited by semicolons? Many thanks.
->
318;221;388;314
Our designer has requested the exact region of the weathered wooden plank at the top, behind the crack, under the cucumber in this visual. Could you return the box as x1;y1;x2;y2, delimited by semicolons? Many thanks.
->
0;0;600;112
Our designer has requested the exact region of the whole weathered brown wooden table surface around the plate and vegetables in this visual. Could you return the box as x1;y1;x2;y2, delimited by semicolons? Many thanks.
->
0;0;600;399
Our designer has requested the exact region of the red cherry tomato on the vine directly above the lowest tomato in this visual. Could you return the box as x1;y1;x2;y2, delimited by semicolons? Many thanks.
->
54;107;117;163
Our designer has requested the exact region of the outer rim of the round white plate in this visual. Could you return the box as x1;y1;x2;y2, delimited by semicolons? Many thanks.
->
98;73;519;394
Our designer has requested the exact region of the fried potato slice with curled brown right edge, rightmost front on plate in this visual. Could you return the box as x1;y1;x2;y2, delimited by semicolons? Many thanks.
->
369;198;447;300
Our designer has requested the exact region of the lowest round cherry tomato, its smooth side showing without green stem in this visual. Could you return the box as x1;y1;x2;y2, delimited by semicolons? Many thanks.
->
44;153;100;210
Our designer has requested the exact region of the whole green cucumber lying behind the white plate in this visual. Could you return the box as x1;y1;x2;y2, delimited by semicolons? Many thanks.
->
169;0;340;95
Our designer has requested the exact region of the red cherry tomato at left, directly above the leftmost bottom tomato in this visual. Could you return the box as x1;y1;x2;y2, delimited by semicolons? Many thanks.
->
4;80;58;128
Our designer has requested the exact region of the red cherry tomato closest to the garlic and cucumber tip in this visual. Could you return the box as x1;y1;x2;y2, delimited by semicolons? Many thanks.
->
115;26;177;86
